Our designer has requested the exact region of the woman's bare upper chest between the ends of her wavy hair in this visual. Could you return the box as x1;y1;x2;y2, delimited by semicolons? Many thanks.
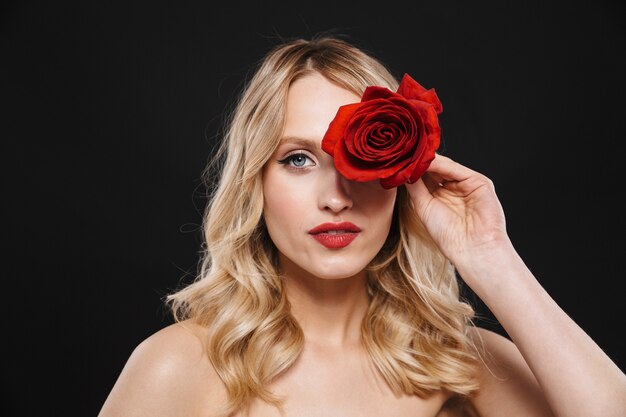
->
236;342;446;417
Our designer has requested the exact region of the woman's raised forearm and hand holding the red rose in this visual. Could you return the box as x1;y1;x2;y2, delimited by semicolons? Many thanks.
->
407;155;626;417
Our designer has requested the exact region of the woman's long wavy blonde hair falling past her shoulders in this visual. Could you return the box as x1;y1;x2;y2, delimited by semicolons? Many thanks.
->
167;35;477;415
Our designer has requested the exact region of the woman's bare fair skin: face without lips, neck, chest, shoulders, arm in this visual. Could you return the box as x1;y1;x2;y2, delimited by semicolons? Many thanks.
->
99;74;626;417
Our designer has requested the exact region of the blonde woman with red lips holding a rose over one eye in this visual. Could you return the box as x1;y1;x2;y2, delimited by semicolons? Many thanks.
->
100;36;626;417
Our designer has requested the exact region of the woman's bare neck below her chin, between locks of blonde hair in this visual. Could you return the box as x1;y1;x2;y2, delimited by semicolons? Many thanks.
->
282;255;369;347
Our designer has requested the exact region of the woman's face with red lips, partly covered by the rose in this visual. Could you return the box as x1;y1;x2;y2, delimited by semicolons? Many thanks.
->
263;73;396;279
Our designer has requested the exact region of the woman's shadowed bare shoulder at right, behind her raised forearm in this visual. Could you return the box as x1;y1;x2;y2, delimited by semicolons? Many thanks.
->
470;327;553;417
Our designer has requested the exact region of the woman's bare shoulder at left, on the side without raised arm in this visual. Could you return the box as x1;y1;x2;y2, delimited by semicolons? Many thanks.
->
99;321;225;417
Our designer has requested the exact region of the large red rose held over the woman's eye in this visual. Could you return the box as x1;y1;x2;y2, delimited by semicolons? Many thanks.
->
322;74;442;189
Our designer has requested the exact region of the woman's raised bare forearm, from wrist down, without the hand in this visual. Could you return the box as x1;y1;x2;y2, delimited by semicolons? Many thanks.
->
455;244;626;417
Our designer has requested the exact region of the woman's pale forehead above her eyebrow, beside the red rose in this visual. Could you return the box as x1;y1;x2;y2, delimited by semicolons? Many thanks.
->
282;72;361;141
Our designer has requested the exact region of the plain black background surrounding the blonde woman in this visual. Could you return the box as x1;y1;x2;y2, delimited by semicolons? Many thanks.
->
0;1;626;416
